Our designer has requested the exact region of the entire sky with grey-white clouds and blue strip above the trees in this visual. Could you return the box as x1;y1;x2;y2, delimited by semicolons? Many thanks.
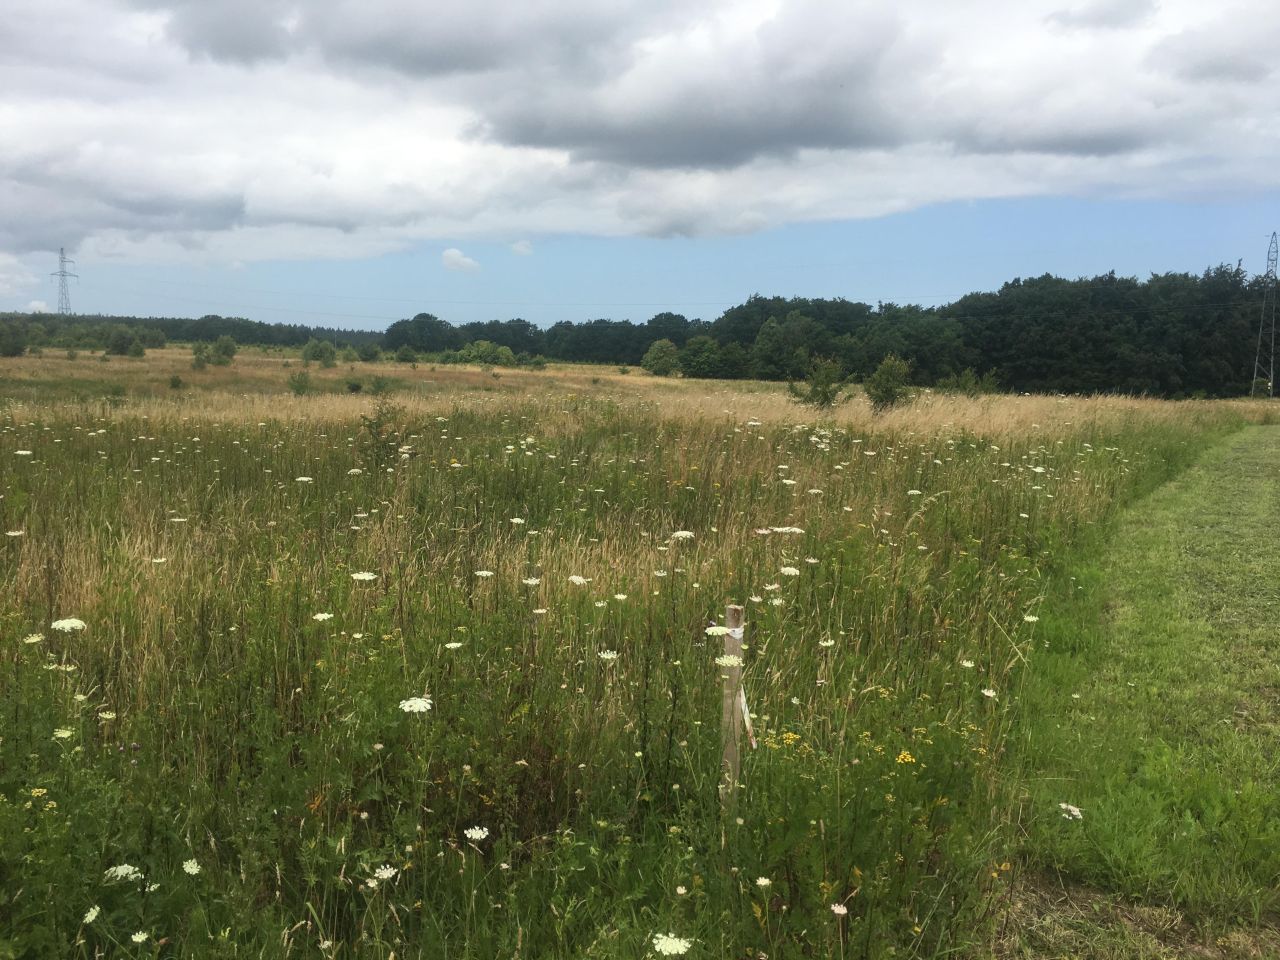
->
0;0;1280;328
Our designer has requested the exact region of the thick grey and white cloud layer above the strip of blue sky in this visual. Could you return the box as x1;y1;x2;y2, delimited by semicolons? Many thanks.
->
0;0;1280;264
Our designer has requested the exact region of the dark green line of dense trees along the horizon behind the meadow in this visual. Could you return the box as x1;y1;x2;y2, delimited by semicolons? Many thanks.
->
0;265;1263;397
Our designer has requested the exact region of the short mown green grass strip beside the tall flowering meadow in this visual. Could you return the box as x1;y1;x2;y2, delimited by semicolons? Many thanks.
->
1006;426;1280;957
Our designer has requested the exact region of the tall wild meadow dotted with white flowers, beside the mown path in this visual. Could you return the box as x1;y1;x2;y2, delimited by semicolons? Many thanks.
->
0;349;1268;960
